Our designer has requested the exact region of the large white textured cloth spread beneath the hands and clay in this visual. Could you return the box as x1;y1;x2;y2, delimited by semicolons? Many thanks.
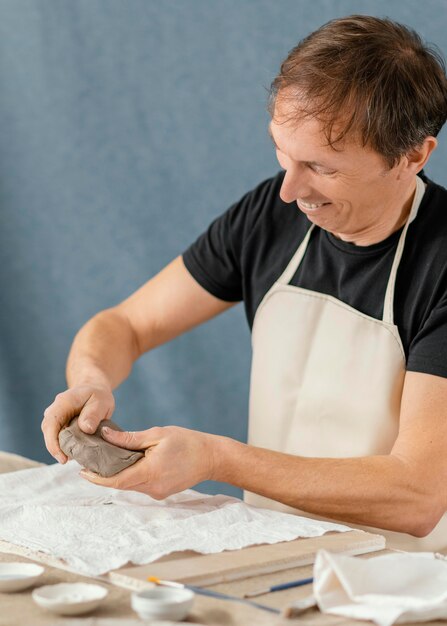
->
0;461;351;575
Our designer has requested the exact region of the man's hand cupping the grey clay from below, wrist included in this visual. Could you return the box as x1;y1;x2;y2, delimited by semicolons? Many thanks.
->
81;426;221;500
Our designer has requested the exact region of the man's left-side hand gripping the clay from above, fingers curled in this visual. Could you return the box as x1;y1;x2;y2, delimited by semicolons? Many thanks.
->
41;385;115;463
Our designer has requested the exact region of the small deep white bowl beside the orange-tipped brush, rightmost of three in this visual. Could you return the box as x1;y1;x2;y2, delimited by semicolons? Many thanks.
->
131;587;194;622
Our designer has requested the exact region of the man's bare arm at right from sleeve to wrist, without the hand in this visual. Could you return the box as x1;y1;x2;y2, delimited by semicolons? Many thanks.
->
214;372;447;536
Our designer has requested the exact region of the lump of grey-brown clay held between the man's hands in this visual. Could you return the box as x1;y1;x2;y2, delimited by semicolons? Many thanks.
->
59;417;144;476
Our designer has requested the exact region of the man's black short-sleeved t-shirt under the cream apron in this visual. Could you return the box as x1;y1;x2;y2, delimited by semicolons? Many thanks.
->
183;171;447;378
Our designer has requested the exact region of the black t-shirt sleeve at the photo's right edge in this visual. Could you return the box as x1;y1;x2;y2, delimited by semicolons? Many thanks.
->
407;291;447;378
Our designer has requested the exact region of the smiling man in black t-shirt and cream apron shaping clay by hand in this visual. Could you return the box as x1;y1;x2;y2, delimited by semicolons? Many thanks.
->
42;16;447;549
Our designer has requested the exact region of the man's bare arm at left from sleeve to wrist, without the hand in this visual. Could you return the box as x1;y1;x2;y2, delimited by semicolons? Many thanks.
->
67;257;235;388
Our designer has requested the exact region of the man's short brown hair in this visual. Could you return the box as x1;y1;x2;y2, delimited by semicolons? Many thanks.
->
268;15;447;167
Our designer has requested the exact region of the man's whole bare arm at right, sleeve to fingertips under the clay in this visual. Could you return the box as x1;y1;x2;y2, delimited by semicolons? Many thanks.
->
82;372;447;537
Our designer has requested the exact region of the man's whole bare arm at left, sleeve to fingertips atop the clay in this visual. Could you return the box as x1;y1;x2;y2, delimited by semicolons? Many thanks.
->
42;257;235;462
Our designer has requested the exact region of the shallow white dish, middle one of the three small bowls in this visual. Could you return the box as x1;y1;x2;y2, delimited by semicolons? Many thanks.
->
31;583;108;615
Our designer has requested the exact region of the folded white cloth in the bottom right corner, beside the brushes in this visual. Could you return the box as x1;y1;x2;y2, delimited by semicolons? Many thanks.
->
314;550;447;626
